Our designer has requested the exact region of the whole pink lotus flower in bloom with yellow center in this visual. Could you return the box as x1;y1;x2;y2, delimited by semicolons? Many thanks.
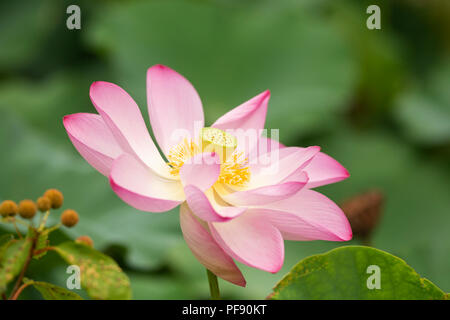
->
64;65;352;286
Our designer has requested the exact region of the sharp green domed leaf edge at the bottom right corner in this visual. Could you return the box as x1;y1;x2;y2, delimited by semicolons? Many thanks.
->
270;246;447;300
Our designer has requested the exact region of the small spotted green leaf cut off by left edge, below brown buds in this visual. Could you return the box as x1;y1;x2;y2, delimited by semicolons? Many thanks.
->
0;238;32;292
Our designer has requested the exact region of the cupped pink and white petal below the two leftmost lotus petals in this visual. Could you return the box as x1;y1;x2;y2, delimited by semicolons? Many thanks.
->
109;154;184;212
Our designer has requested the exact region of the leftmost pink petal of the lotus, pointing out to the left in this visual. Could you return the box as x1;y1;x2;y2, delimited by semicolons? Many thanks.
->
63;113;122;176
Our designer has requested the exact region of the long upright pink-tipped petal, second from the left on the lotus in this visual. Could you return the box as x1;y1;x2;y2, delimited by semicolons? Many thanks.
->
89;81;170;177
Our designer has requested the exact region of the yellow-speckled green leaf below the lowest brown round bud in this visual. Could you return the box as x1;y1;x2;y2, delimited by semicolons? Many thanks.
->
55;242;131;300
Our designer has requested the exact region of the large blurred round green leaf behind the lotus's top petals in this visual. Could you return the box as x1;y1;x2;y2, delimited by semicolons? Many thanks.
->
86;1;356;143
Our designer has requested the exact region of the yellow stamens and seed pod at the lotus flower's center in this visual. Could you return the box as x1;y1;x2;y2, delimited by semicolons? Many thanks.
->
167;128;250;186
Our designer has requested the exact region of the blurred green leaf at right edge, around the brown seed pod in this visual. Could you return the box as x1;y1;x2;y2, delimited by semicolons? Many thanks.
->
314;128;450;292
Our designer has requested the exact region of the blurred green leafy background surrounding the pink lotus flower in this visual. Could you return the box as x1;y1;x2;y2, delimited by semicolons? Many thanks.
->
0;0;450;299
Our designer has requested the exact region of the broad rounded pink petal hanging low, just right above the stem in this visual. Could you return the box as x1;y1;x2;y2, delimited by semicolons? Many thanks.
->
209;213;284;273
